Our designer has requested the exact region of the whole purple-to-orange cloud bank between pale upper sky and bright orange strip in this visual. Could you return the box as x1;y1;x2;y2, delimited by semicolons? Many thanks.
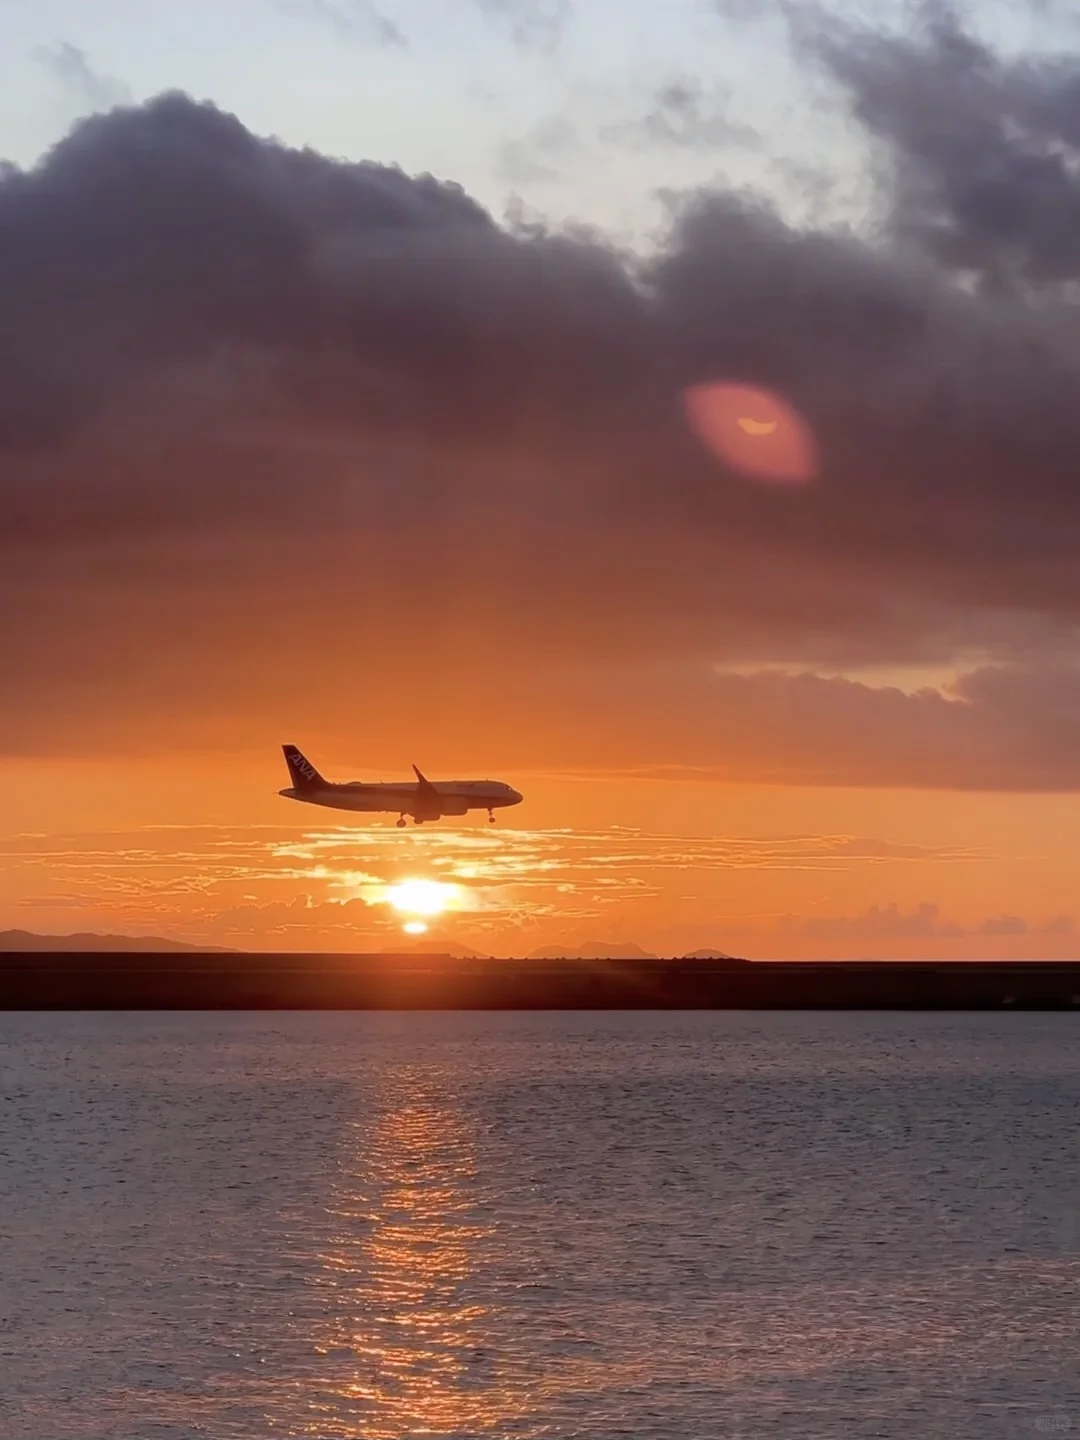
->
0;6;1080;789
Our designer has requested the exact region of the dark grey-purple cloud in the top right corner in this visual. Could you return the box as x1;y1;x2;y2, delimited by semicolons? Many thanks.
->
808;0;1080;291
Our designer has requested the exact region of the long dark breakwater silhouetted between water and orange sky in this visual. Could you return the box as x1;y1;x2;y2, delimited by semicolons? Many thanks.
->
0;952;1080;1011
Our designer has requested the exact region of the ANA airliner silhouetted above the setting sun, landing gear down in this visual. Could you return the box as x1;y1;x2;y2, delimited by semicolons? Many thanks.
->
278;744;524;825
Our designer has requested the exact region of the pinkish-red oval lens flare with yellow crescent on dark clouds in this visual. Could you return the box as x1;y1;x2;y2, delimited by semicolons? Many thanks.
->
683;382;818;485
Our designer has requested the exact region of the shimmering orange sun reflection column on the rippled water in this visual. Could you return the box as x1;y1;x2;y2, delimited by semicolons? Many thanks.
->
294;1077;523;1440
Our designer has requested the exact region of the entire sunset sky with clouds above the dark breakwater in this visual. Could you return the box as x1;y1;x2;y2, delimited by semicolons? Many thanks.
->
0;0;1080;958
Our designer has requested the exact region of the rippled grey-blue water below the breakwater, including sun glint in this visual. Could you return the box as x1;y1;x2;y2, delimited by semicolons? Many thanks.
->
0;1012;1080;1440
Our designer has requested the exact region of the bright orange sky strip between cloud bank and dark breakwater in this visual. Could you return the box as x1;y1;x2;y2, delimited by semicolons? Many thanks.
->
0;753;1080;958
